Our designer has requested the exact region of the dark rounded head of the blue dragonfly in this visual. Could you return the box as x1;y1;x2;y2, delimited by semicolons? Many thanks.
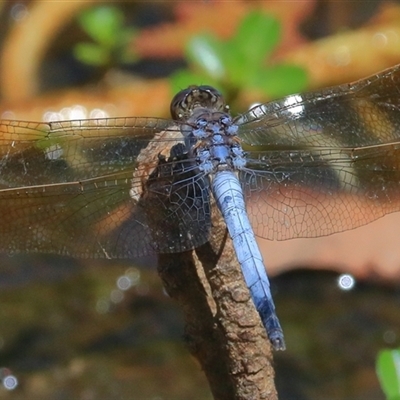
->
171;85;229;121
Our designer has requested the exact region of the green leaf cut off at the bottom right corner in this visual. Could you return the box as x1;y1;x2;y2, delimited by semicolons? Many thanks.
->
376;349;400;400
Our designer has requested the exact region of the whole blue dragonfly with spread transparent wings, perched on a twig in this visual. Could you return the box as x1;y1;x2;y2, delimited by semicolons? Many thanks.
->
0;66;400;350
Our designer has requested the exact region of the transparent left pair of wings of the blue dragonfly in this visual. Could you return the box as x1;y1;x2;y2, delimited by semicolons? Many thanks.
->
0;118;210;258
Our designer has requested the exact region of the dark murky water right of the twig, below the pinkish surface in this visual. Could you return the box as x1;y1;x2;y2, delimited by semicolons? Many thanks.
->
274;270;400;400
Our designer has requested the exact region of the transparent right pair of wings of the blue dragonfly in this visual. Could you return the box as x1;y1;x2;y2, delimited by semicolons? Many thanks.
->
238;66;400;240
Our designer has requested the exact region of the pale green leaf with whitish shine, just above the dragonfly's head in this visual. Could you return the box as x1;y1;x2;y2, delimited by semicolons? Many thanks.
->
186;34;226;80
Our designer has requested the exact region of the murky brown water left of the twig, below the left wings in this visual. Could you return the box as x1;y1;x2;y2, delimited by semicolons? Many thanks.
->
0;256;211;400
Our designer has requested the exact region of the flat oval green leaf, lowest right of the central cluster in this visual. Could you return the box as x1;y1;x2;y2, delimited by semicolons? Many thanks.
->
248;64;308;98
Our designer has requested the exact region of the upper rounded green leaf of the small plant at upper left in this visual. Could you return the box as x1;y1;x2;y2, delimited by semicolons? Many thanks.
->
79;6;124;47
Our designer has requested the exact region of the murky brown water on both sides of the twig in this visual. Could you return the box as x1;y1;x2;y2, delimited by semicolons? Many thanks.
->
0;256;400;400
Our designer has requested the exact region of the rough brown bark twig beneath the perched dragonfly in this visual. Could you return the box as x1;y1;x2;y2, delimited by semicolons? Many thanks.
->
158;211;278;400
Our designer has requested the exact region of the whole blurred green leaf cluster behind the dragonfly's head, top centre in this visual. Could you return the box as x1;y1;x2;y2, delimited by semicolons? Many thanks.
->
171;12;307;106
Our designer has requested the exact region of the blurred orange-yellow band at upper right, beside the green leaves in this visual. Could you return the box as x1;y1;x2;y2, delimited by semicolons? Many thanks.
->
282;4;400;88
